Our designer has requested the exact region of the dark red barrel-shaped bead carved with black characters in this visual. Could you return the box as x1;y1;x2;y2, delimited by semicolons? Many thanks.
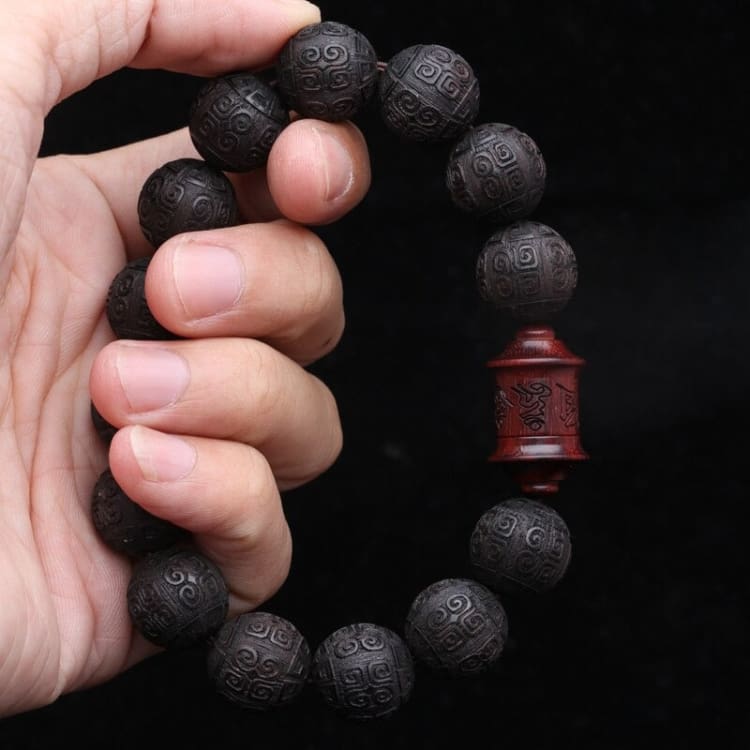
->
487;326;588;495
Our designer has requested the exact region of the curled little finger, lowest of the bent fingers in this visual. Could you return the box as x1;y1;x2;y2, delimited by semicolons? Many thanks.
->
110;427;292;615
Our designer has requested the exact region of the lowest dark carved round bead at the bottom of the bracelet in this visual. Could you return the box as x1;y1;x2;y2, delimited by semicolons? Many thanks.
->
310;623;414;720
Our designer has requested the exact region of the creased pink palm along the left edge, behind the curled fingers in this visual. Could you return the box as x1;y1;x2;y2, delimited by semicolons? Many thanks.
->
0;157;153;703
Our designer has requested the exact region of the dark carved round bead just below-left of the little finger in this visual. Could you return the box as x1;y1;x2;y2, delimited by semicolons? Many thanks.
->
127;548;229;649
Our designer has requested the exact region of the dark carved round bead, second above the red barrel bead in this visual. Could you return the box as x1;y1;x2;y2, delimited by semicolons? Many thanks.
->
446;123;547;224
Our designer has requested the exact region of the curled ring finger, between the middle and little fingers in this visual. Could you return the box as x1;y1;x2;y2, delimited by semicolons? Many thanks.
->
89;338;342;489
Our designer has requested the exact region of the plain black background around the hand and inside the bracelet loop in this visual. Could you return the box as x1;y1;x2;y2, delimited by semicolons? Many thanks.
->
0;0;750;750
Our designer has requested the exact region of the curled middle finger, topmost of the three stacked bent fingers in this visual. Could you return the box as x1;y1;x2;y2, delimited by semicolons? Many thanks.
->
146;220;344;364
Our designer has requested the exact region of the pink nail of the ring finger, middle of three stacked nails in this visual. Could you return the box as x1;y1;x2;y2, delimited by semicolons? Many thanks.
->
115;344;190;414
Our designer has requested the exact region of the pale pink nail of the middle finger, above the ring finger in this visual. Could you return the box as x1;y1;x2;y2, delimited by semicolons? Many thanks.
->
172;240;244;320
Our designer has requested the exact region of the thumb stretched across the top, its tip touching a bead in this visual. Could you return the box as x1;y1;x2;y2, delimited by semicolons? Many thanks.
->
0;0;320;280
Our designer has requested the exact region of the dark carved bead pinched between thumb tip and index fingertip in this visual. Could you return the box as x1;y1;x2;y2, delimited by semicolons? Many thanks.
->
276;21;378;122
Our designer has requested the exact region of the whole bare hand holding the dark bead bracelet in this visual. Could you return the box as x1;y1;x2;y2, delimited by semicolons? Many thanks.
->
0;0;370;716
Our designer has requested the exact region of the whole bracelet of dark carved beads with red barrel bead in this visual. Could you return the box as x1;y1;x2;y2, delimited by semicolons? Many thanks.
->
91;21;588;720
